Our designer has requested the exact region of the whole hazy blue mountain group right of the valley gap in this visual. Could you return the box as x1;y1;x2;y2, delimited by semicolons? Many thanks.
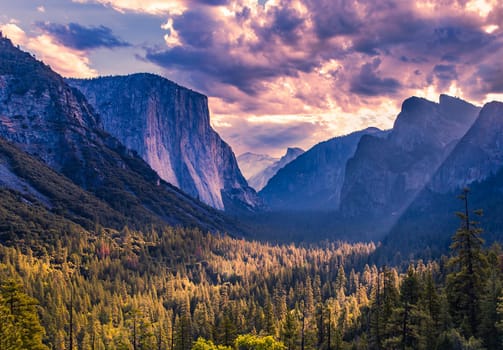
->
255;95;503;261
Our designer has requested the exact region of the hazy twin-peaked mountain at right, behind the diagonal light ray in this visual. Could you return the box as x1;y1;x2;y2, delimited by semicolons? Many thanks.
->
340;95;480;237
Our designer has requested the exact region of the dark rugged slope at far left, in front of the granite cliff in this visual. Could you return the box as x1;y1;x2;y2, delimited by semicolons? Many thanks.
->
0;37;238;234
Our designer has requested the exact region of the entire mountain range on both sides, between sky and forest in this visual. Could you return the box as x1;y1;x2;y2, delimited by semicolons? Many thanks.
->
0;32;503;259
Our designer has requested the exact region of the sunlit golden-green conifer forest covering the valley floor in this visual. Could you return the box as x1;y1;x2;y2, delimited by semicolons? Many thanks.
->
0;192;503;350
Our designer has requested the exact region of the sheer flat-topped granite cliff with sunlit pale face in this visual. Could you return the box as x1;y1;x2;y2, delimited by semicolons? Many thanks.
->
67;74;258;211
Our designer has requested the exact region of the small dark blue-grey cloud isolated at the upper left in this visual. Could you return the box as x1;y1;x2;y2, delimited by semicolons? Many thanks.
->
37;22;130;50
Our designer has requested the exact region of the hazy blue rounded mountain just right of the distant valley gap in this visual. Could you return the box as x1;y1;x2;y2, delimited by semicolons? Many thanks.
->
259;128;386;211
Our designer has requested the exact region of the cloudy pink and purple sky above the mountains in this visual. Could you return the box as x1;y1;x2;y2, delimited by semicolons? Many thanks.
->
0;0;503;156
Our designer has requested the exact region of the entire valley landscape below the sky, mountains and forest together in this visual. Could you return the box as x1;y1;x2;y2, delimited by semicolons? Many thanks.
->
0;30;503;350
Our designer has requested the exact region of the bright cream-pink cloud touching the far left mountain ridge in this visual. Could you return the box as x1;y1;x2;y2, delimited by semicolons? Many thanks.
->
0;23;98;78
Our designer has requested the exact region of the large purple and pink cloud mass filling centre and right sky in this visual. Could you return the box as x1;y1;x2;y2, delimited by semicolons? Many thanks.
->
137;0;503;153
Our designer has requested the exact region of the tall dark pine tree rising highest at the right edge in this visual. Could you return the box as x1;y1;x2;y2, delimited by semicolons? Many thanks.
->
447;189;487;338
